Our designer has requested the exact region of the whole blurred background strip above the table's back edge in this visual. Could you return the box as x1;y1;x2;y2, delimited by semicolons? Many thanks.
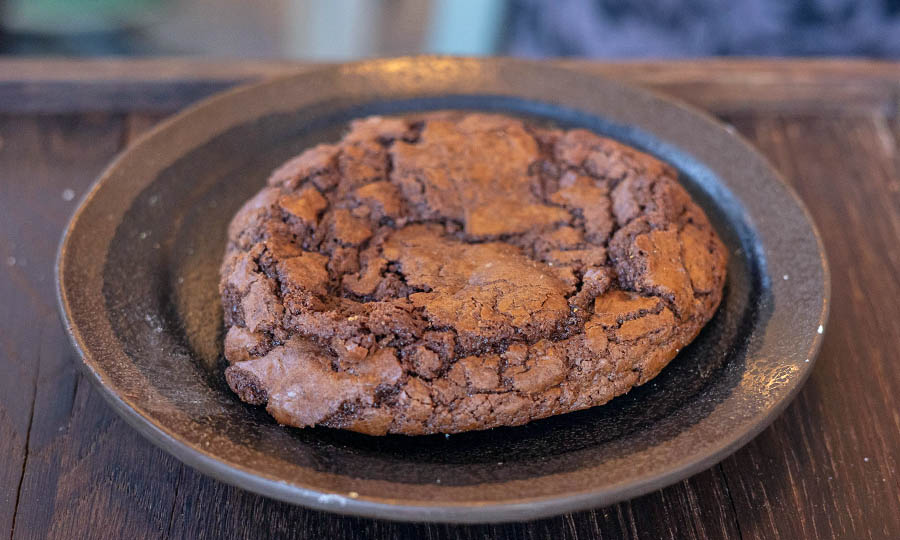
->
0;0;900;60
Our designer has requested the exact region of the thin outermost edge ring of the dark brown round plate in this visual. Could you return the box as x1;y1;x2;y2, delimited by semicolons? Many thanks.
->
54;56;831;523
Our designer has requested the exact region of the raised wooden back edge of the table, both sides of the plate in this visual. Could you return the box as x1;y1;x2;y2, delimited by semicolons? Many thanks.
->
0;58;900;115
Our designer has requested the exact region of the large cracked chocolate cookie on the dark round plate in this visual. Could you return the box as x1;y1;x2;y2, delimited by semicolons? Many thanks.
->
221;112;726;435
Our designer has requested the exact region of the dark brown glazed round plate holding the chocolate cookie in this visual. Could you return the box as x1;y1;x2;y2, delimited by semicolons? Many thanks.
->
57;58;829;522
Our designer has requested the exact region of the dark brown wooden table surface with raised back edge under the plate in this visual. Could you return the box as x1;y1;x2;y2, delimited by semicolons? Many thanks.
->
0;60;900;539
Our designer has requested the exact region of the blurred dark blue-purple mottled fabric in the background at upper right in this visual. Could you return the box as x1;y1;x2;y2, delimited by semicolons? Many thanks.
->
505;0;900;58
